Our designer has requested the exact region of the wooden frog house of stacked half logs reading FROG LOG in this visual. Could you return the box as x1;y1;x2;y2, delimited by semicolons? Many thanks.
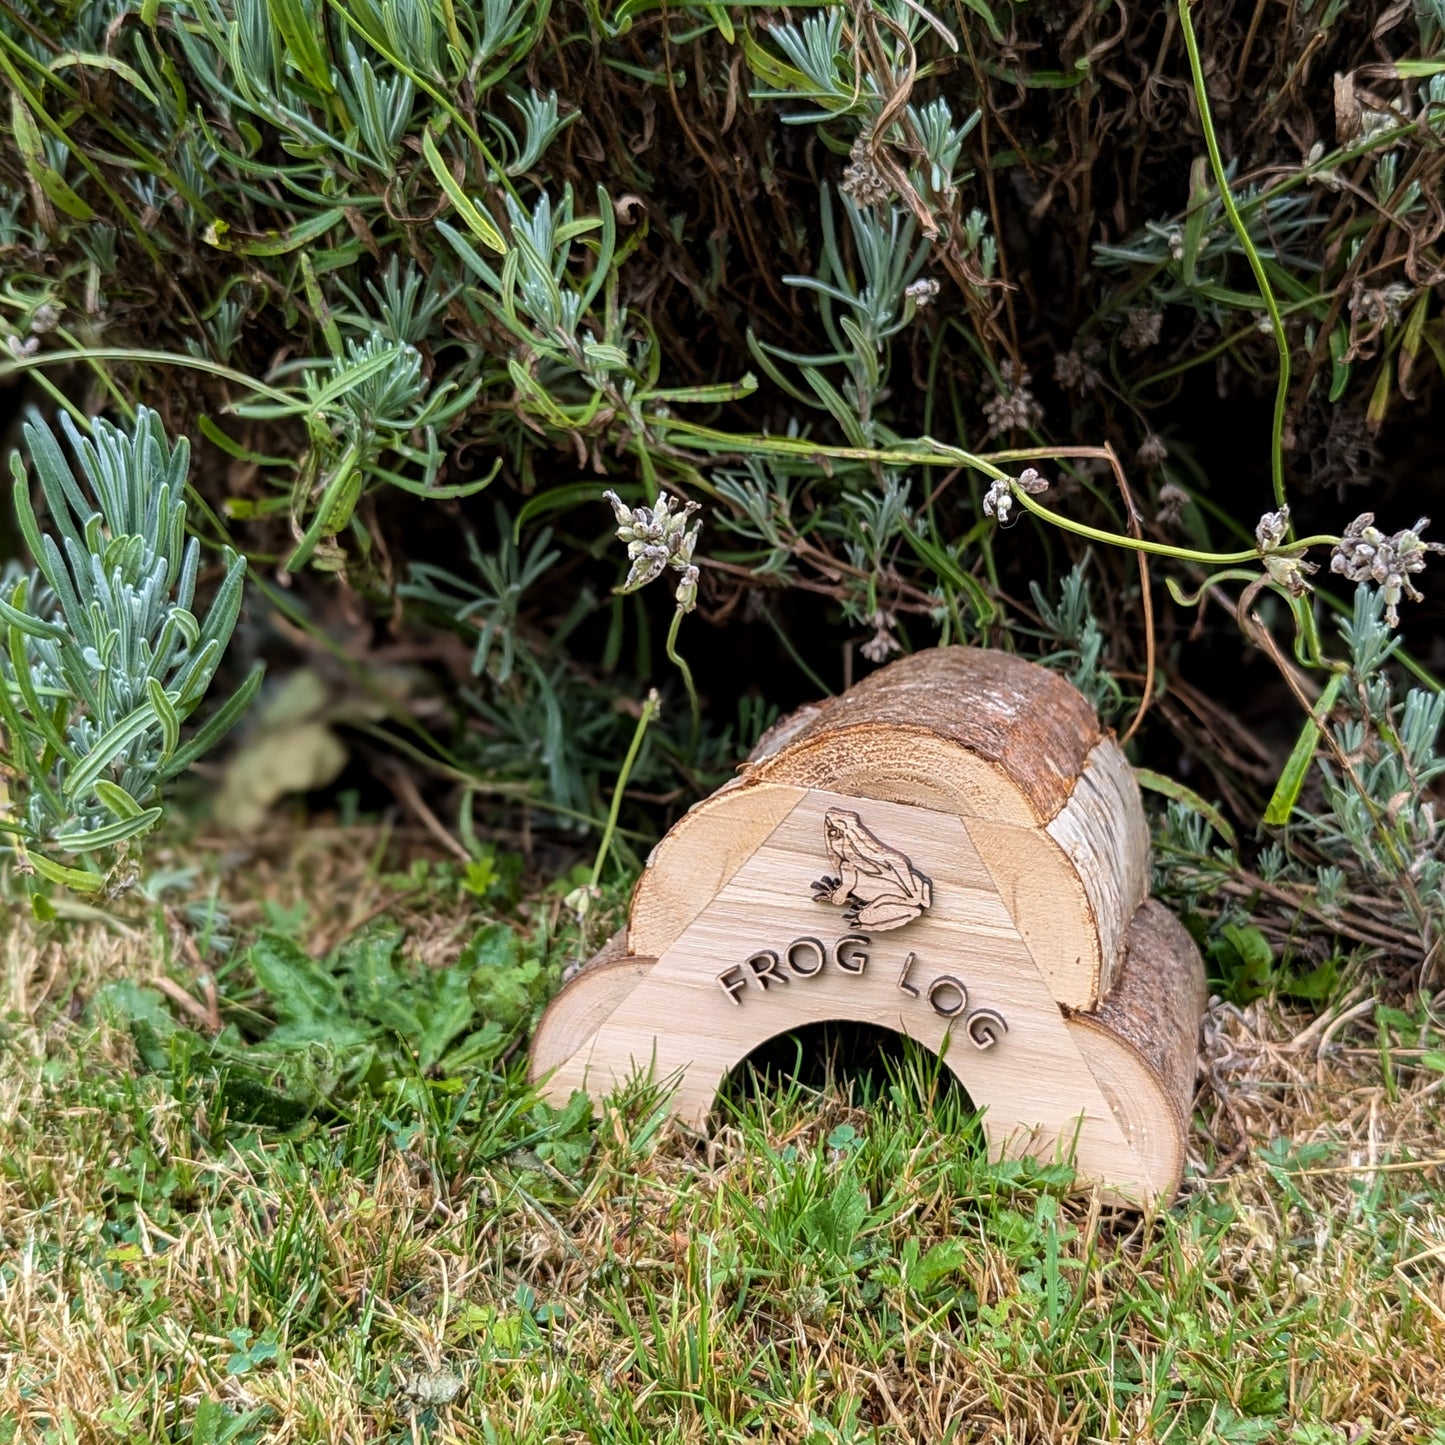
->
532;647;1205;1207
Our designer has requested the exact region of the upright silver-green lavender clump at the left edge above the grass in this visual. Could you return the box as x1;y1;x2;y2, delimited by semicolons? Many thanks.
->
0;409;260;892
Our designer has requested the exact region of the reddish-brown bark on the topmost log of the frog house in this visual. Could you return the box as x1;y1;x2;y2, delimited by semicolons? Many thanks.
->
756;647;1103;822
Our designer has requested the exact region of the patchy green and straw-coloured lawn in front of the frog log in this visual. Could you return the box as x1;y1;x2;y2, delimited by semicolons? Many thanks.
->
0;835;1445;1445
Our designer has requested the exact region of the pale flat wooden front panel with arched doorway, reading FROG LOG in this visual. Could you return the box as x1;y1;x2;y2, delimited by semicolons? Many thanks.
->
533;792;1182;1202
